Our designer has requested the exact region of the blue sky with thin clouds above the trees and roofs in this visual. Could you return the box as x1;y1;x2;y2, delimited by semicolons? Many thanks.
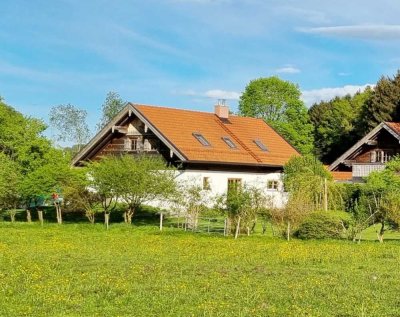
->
0;0;400;129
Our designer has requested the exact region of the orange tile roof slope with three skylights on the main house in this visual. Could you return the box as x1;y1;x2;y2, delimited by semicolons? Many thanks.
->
133;104;300;166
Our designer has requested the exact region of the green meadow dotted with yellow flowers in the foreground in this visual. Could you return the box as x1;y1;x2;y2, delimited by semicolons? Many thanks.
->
0;222;400;317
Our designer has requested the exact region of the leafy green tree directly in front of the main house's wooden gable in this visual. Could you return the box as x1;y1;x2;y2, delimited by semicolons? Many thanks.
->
87;155;176;223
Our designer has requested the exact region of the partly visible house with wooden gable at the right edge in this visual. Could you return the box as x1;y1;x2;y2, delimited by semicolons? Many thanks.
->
329;122;400;182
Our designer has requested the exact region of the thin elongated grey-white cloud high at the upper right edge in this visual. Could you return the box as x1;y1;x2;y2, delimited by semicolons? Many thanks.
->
297;24;400;40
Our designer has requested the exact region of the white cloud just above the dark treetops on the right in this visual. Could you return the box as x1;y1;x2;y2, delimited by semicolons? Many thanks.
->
301;84;374;106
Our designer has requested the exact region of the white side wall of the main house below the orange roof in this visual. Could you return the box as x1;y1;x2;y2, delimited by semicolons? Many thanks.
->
176;170;287;208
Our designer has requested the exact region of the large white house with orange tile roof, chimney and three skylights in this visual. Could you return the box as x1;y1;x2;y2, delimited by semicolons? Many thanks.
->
73;103;299;207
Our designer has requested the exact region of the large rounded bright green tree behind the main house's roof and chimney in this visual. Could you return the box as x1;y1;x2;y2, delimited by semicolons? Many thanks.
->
239;77;313;154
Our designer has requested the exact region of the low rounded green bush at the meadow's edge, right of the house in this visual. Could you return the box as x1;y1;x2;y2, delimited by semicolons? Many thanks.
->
296;211;352;239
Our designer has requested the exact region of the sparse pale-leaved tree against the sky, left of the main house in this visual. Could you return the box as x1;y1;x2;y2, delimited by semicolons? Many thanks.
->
50;104;90;152
